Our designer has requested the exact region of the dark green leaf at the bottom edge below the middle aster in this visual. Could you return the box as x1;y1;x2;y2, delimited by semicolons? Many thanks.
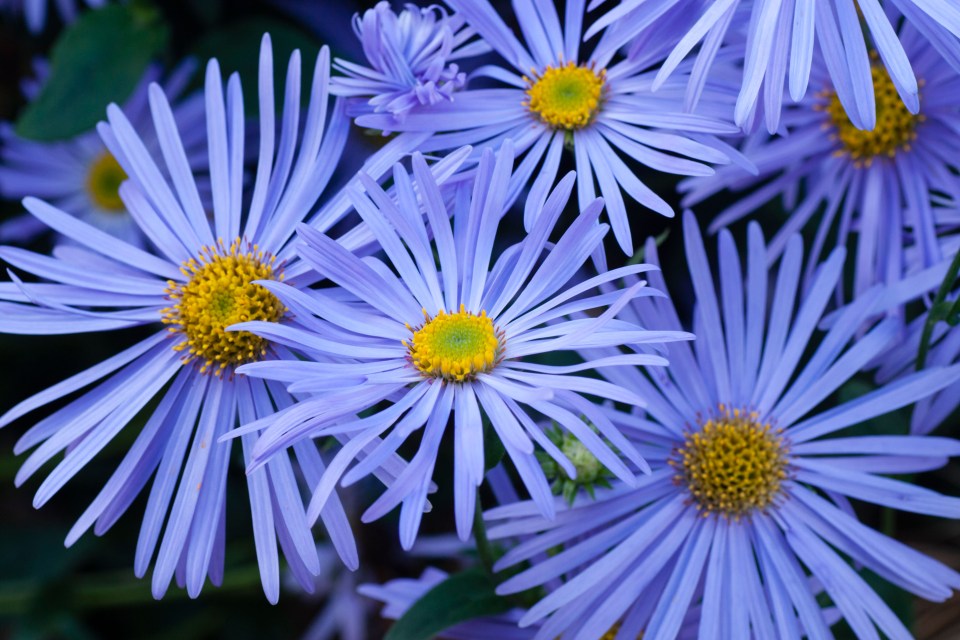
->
384;567;512;640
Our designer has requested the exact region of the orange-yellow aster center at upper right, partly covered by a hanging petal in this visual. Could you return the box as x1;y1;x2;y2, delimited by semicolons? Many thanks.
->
821;59;924;167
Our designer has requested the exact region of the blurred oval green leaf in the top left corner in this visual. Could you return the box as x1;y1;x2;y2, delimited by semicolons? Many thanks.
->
16;2;169;142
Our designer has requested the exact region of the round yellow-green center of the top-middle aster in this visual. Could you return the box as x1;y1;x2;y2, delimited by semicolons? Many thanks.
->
524;62;606;130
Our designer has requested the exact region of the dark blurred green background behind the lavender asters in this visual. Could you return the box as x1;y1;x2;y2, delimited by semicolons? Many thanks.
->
0;0;960;640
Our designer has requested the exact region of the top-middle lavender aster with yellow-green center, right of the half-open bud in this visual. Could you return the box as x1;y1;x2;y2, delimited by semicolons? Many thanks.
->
356;0;737;254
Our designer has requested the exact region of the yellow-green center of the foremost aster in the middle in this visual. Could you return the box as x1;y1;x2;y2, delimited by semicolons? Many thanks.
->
403;304;503;382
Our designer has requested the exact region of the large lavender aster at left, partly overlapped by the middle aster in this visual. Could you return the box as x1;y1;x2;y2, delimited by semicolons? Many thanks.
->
0;36;420;601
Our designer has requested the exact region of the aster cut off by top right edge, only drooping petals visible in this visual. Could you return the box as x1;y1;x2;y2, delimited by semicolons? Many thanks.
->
587;0;960;132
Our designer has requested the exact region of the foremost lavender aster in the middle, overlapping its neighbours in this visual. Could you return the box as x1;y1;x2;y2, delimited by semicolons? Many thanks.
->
236;142;689;549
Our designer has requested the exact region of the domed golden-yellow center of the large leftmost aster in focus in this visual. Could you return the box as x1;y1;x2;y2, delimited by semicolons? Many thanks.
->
161;238;286;376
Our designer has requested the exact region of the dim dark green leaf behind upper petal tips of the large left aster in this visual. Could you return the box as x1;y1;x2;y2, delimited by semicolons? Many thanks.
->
191;17;320;116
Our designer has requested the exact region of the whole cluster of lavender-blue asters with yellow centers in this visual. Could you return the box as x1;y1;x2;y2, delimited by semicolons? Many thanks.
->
0;0;960;640
